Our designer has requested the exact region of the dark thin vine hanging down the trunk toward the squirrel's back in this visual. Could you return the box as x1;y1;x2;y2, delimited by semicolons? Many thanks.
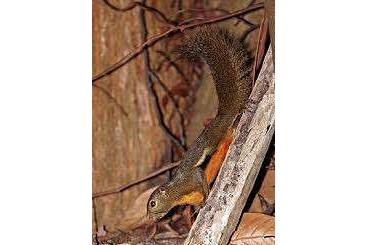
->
139;2;186;150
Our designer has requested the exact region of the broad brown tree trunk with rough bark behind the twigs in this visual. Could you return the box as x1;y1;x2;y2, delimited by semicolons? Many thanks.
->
92;0;191;230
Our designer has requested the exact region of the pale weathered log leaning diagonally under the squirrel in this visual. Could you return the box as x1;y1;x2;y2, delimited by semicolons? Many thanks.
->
185;49;275;245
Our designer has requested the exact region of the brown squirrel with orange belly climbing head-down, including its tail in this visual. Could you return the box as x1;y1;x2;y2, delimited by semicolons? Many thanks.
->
147;25;253;221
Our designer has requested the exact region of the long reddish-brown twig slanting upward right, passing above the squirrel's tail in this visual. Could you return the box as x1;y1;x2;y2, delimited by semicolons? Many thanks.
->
92;3;263;83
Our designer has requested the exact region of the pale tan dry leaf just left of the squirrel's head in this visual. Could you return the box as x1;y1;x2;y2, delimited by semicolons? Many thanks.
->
119;186;157;231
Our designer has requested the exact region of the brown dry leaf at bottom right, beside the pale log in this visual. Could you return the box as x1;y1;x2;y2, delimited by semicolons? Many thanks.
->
229;213;275;245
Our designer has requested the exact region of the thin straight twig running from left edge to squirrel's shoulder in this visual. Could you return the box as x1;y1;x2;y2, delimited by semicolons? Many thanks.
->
92;161;180;199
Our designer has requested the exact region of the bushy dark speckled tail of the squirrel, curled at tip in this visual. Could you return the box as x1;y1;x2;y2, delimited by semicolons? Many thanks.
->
176;25;252;115
